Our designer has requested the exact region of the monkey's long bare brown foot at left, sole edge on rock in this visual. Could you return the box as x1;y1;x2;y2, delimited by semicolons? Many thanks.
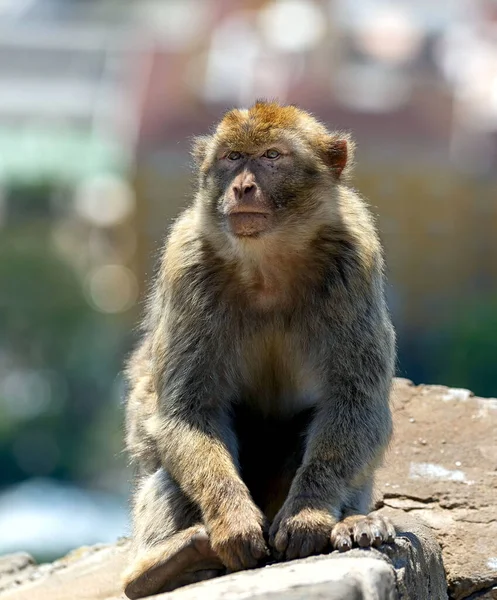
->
124;526;226;600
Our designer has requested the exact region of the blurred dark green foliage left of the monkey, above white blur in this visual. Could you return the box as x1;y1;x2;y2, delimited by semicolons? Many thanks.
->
0;183;128;485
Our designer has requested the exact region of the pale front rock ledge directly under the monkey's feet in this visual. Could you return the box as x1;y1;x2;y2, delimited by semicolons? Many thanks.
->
0;509;447;600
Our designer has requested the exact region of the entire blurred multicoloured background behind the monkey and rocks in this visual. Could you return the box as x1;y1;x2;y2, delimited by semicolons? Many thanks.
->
0;0;497;560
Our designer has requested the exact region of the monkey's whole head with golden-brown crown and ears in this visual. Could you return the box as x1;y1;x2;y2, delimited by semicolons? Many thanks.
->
193;101;353;239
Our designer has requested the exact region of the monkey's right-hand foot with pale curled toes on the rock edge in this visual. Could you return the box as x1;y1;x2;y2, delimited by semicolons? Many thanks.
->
331;514;395;552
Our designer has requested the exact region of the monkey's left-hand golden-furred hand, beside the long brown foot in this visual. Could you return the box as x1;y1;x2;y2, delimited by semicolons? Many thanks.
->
209;500;269;571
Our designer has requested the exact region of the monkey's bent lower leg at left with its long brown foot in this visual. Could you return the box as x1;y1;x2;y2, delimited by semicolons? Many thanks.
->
123;469;225;599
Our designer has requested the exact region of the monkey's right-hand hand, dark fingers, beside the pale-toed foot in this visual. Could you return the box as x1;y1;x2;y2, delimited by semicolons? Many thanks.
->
269;505;336;560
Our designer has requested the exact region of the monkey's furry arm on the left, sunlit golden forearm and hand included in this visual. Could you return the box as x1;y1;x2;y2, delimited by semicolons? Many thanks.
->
148;299;267;570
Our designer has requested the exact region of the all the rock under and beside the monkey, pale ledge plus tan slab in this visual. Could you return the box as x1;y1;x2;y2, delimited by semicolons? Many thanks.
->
0;380;497;600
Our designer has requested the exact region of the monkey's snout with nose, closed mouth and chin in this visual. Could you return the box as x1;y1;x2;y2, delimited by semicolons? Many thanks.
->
224;171;272;236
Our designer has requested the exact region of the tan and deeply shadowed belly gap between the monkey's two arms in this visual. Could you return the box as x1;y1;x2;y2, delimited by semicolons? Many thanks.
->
224;319;319;518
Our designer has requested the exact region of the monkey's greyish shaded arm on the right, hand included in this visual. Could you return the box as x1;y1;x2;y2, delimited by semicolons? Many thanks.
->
270;308;393;559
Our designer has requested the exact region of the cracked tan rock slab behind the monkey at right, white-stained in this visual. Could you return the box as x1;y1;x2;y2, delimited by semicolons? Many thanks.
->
377;379;497;600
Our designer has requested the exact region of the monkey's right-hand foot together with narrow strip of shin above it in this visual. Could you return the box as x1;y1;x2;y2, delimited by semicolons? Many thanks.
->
331;477;395;552
